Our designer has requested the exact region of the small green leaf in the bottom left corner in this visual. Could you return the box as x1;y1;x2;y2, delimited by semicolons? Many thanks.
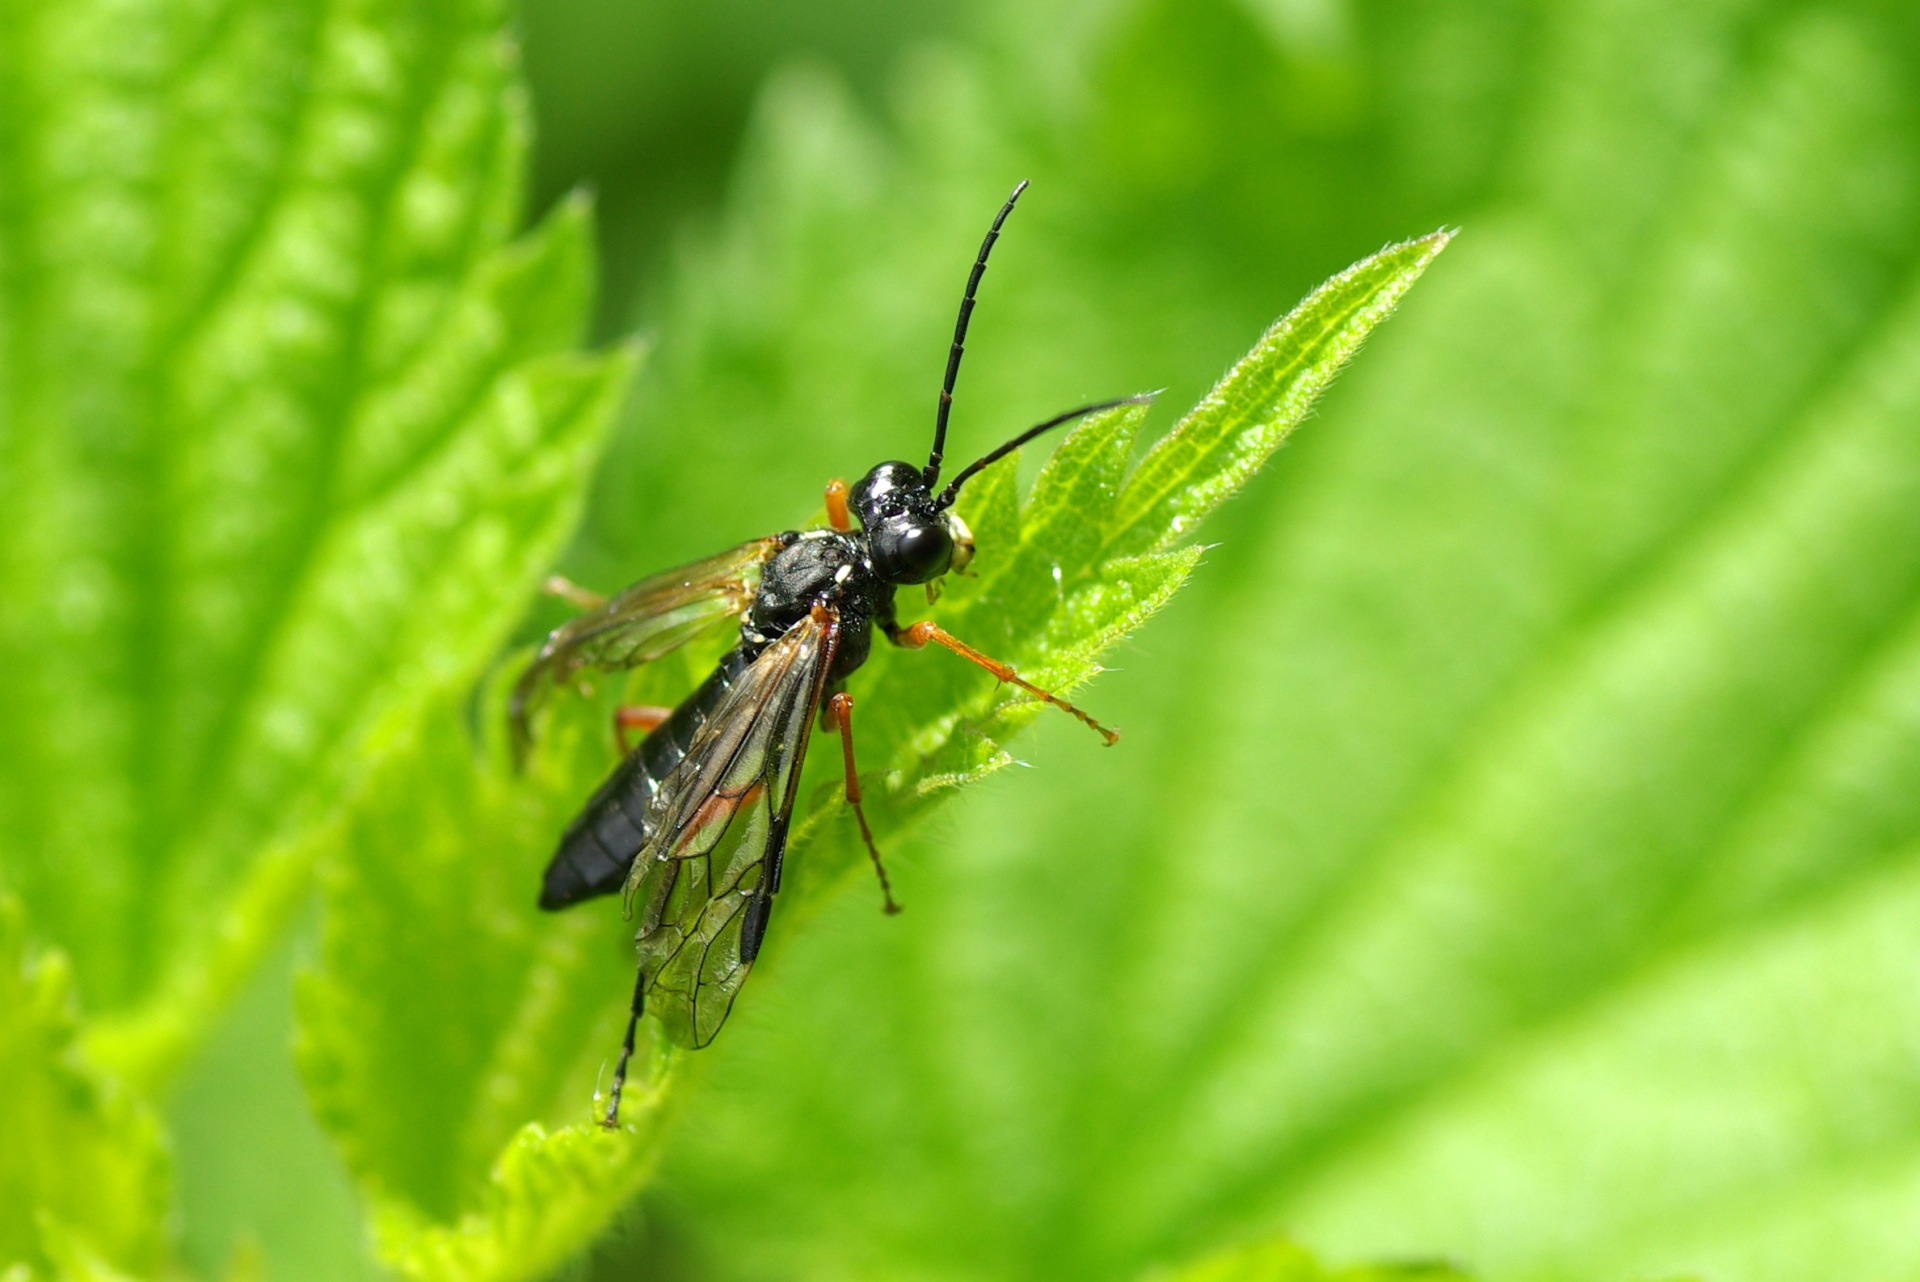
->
0;894;167;1278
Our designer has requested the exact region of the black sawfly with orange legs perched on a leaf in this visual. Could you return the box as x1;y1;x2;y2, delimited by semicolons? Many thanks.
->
509;182;1146;1127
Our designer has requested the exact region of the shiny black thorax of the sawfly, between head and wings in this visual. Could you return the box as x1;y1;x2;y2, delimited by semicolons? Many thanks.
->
739;530;893;679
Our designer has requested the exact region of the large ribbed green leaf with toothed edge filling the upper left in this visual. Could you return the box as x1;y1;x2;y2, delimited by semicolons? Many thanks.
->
0;0;630;1080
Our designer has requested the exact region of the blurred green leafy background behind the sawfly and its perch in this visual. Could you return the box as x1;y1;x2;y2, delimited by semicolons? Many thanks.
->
145;0;1920;1280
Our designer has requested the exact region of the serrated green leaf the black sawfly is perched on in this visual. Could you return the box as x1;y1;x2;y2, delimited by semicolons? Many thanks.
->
301;122;1444;1278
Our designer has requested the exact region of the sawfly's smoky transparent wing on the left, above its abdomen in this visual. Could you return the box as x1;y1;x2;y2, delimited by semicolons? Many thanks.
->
509;537;780;754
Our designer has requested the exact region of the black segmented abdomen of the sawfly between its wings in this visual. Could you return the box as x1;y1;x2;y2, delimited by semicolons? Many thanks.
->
540;649;751;912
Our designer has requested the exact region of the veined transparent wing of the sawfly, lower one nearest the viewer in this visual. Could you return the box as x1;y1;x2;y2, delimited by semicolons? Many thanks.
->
626;606;839;1046
